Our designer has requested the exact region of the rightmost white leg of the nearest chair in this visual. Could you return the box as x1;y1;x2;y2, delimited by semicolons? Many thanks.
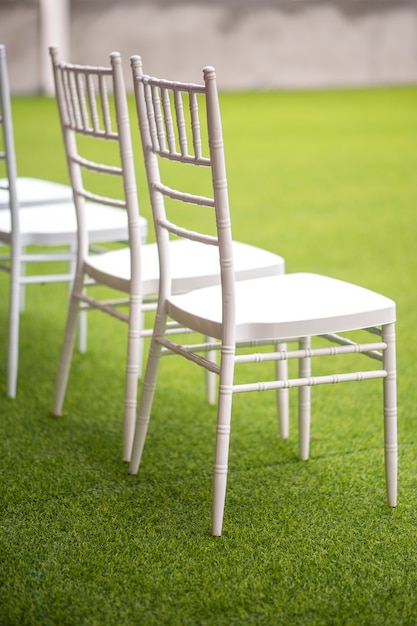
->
382;324;398;507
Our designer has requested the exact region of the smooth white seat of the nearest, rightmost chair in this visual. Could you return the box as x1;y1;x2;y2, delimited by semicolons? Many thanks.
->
167;273;395;342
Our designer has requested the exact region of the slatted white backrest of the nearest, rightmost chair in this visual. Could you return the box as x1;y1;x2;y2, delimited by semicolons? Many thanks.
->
131;56;235;344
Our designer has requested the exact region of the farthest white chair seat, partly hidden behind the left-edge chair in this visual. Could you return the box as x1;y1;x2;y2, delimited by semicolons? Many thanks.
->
0;176;72;209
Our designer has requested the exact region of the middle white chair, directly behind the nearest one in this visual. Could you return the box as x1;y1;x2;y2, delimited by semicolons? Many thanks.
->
50;47;287;461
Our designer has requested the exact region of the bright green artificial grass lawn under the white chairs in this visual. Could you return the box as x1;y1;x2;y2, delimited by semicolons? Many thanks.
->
0;88;417;626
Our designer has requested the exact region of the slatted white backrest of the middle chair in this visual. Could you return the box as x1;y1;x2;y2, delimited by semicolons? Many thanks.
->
49;46;141;278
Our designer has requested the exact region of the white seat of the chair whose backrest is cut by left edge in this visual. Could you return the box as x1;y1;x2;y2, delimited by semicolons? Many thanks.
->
0;202;147;245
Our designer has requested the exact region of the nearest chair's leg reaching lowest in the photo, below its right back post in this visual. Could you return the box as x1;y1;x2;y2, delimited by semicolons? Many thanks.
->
211;349;234;537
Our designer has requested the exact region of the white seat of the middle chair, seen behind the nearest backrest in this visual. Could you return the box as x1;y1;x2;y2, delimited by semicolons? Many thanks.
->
86;239;284;295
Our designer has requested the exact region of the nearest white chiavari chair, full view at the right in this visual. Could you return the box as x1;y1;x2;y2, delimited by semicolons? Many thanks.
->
129;57;397;535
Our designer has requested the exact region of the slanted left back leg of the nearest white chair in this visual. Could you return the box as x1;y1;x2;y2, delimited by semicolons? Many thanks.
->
129;314;166;474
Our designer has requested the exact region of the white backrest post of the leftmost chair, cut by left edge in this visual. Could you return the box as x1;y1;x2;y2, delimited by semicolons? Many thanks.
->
0;45;19;234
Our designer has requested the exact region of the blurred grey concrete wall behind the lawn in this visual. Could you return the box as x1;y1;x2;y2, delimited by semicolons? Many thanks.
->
0;0;417;93
